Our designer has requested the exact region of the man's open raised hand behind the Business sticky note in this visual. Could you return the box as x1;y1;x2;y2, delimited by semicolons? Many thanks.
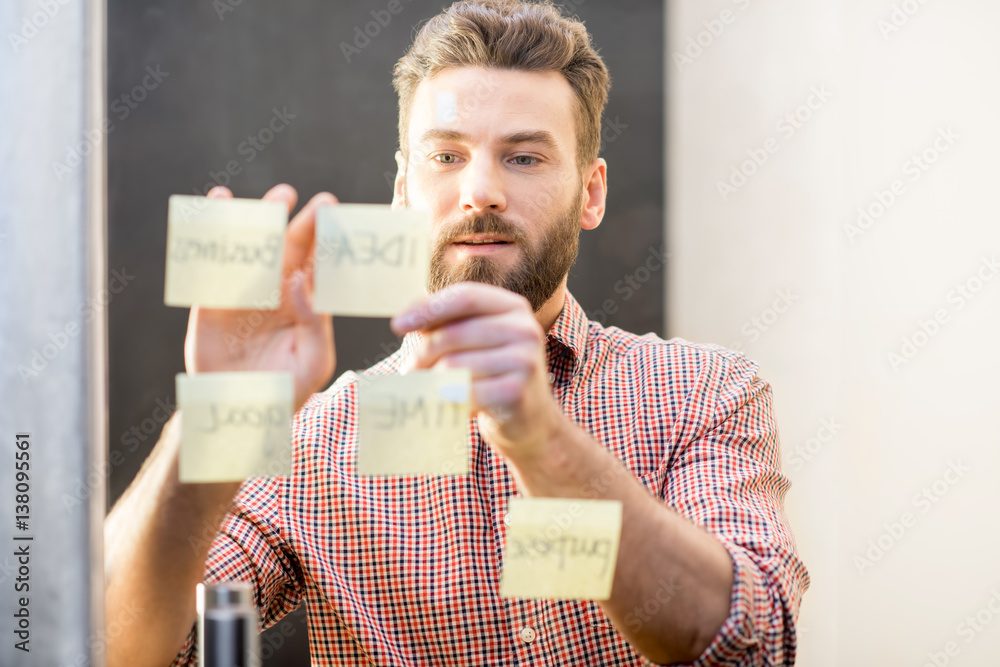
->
184;184;338;411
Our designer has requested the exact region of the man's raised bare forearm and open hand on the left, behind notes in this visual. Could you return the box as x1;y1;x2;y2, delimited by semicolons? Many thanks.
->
105;185;337;667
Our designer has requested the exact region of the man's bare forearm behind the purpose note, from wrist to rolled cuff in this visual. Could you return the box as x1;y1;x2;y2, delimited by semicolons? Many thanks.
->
512;418;733;664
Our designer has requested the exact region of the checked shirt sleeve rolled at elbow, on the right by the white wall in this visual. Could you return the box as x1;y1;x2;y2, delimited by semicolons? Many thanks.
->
665;351;809;667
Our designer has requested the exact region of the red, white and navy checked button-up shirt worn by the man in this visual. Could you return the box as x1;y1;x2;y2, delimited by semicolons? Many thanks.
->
174;295;809;666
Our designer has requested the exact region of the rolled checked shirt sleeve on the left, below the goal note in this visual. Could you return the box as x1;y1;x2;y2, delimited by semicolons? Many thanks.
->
172;477;305;667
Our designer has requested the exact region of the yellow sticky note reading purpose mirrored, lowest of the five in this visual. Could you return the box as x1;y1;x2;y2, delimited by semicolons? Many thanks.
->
500;498;622;600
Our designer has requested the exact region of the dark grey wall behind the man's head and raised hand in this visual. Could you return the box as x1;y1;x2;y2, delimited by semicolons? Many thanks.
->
107;0;664;665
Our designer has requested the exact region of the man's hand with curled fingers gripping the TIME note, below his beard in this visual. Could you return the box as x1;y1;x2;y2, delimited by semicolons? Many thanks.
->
392;282;566;466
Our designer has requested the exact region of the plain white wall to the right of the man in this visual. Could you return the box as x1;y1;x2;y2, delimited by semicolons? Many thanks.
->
666;0;1000;667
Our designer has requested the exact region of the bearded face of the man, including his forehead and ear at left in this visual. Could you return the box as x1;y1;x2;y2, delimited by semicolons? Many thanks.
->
395;67;584;311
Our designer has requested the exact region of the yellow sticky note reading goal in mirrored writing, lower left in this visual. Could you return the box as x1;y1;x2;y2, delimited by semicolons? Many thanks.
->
177;372;294;482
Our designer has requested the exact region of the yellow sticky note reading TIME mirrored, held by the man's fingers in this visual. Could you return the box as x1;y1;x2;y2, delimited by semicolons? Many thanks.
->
357;368;472;476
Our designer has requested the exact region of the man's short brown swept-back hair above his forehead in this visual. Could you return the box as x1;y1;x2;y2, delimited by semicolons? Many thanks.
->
392;0;611;173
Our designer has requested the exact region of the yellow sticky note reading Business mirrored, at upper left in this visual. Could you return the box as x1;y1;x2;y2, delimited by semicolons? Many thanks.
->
163;195;288;310
